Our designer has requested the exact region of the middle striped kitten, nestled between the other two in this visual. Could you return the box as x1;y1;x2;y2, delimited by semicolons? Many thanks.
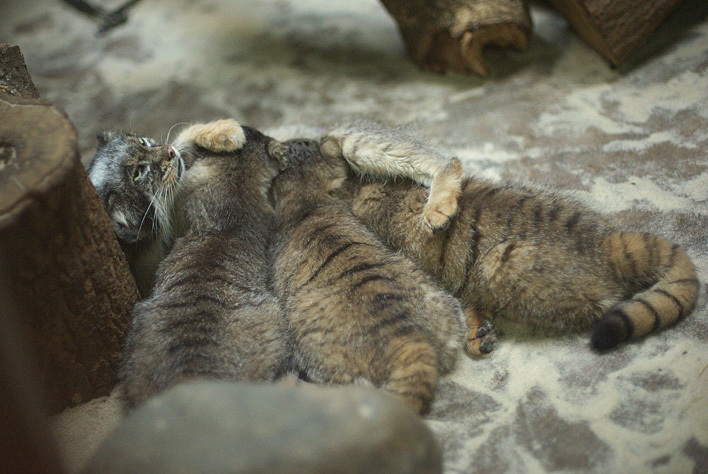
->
271;141;464;412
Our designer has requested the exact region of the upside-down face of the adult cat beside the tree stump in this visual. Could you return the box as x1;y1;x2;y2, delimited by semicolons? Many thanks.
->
88;132;184;243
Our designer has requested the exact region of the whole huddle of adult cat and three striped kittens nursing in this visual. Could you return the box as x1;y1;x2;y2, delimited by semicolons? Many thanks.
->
89;120;699;413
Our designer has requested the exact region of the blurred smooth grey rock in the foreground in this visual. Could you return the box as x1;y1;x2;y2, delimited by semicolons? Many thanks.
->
86;381;442;473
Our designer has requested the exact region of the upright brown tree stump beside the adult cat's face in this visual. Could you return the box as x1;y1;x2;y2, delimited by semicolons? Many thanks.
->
0;45;138;412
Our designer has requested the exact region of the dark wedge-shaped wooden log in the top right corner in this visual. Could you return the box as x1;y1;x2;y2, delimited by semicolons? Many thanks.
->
549;0;682;66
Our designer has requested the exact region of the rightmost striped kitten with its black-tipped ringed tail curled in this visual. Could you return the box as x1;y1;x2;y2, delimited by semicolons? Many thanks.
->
349;178;699;350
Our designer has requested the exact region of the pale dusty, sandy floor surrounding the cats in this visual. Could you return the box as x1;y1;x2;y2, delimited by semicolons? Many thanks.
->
0;0;708;472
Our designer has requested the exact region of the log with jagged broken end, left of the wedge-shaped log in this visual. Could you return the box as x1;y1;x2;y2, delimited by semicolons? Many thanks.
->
381;0;531;76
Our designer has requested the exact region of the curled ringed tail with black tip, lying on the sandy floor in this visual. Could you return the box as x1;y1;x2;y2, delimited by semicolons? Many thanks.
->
591;232;699;351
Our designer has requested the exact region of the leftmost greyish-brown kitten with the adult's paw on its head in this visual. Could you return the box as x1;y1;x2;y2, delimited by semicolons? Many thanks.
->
120;121;290;408
